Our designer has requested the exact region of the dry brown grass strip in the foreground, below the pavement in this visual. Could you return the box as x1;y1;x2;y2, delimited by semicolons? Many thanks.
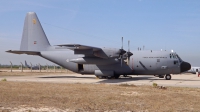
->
0;81;200;112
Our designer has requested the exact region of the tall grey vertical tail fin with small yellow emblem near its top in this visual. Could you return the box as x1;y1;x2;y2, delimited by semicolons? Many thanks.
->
20;12;50;51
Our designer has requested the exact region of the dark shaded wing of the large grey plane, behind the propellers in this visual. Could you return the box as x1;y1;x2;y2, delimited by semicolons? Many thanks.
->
56;44;108;58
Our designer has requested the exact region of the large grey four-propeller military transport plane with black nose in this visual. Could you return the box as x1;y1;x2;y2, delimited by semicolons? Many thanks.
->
6;12;191;80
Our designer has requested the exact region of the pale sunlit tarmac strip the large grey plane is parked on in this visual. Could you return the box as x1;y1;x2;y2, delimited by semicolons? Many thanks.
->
0;74;200;88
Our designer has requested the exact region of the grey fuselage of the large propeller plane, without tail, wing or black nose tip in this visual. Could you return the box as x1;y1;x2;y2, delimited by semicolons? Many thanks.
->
40;47;182;75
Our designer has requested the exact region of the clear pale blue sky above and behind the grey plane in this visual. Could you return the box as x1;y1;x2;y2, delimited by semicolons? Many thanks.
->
0;0;200;66
